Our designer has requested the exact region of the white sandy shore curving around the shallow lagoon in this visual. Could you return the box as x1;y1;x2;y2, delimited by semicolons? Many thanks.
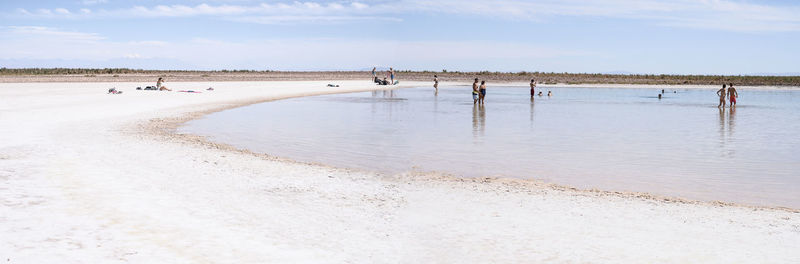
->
0;81;800;263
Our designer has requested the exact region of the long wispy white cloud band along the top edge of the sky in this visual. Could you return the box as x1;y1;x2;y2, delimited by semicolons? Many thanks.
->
9;0;800;32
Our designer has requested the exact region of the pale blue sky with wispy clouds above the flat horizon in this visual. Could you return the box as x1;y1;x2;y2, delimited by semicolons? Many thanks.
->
0;0;800;75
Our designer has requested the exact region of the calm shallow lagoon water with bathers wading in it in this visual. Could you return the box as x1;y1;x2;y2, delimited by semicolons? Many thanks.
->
181;87;800;208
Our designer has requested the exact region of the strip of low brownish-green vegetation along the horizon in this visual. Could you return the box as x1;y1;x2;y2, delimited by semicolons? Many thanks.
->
0;68;800;86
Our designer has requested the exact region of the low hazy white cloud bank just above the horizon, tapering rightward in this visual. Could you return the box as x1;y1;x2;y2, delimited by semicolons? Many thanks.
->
0;26;586;70
